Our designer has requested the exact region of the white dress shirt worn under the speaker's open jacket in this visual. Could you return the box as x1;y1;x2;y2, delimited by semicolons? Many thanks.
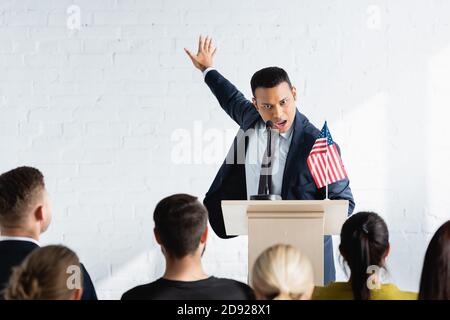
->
203;67;293;199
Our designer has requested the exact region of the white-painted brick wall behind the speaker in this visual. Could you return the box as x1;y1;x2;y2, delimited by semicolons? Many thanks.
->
0;0;450;299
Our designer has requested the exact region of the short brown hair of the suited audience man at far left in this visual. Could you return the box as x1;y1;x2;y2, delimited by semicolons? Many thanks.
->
0;167;45;227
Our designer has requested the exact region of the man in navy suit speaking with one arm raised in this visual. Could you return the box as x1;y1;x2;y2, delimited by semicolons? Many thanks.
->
185;36;355;284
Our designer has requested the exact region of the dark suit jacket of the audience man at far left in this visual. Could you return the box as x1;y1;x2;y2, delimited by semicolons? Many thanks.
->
0;240;97;300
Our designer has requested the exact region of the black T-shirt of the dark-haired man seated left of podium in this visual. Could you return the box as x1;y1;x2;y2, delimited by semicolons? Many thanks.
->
122;276;255;300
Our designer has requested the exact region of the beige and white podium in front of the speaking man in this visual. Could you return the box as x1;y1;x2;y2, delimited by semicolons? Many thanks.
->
222;200;349;286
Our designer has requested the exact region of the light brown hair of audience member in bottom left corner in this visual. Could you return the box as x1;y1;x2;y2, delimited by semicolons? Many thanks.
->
4;245;83;300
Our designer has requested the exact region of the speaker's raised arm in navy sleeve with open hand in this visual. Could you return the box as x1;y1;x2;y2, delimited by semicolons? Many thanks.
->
184;36;257;126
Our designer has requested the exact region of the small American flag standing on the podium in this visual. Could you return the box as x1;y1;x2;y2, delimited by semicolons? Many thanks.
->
307;121;347;189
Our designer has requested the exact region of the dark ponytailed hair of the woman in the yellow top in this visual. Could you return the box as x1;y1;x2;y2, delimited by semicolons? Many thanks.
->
339;212;389;300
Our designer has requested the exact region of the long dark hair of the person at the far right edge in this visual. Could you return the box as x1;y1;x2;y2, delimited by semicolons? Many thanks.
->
419;220;450;300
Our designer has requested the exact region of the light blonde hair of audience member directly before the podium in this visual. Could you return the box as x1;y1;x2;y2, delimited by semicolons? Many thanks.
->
252;244;314;300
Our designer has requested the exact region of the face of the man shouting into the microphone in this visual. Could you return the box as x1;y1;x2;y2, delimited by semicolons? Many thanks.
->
253;82;297;133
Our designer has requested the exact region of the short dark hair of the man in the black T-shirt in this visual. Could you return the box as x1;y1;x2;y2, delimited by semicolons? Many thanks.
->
153;194;208;258
